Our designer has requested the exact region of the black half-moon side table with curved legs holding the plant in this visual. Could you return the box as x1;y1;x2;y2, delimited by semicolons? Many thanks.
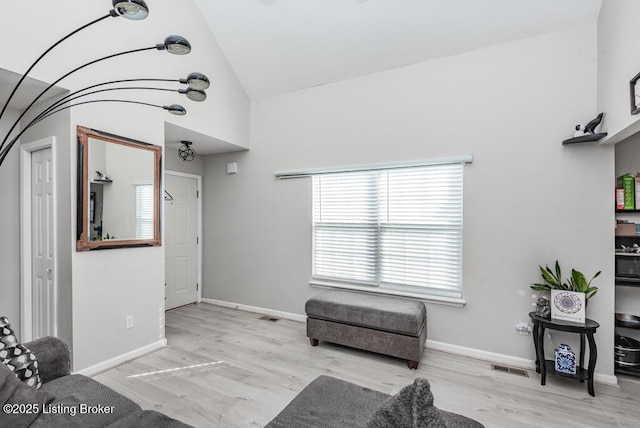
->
529;312;600;397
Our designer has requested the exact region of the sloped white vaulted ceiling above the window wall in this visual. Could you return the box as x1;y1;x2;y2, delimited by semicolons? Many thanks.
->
196;0;602;99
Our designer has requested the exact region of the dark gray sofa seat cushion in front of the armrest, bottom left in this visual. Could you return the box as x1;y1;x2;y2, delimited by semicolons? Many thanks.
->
32;374;140;428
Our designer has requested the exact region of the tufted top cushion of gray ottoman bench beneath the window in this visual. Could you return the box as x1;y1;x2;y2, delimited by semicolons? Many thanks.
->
305;290;427;336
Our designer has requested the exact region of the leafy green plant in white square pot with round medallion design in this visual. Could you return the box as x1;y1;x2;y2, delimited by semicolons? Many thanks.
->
531;260;601;322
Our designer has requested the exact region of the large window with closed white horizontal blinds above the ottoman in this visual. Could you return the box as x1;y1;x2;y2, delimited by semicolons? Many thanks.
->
313;163;463;298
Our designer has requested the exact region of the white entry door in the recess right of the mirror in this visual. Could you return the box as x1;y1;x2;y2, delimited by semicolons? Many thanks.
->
164;174;199;310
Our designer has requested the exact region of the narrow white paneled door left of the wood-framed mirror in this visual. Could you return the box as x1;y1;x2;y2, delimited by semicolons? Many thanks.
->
31;148;56;339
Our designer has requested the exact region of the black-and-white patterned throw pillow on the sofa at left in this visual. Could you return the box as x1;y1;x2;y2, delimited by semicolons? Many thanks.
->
0;317;42;389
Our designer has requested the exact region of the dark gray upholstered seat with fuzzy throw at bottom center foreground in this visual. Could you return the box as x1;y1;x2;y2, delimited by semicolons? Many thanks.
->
266;376;483;428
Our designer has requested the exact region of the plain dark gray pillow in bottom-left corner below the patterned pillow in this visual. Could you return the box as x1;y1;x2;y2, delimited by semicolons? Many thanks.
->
0;364;54;427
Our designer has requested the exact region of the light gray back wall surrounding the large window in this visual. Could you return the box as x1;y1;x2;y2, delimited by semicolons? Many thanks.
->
203;25;614;374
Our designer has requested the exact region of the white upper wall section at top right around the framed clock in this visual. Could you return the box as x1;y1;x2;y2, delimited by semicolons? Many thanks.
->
597;0;640;142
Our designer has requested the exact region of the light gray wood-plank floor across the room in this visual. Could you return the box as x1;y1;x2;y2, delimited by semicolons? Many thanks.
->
95;304;640;428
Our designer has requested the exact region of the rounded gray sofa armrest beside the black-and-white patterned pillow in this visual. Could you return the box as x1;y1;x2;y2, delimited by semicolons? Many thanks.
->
24;336;71;383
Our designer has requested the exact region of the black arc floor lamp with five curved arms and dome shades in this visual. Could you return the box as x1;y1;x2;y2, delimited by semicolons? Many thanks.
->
0;0;210;166
